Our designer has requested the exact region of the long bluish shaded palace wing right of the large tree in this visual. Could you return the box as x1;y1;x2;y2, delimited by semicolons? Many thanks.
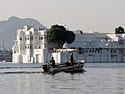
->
64;32;125;63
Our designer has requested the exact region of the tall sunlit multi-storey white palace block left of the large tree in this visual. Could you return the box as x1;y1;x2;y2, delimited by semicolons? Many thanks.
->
12;26;47;63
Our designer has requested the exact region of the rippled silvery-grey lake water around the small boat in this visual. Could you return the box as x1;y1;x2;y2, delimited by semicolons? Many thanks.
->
0;63;125;94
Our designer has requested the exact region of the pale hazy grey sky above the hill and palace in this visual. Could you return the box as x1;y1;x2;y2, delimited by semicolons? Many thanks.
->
0;0;125;32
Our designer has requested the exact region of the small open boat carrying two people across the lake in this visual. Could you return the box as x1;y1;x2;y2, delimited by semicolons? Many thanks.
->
42;60;85;73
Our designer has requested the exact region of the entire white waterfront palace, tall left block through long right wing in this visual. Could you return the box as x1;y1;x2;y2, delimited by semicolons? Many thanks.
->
12;26;125;63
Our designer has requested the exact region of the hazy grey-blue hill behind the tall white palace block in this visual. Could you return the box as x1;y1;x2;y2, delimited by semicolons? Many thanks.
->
0;16;45;48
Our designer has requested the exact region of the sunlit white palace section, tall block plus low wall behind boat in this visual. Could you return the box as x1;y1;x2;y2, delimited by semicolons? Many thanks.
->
12;26;76;63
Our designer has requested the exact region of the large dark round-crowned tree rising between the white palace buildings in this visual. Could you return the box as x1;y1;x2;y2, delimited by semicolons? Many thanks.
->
48;25;75;48
